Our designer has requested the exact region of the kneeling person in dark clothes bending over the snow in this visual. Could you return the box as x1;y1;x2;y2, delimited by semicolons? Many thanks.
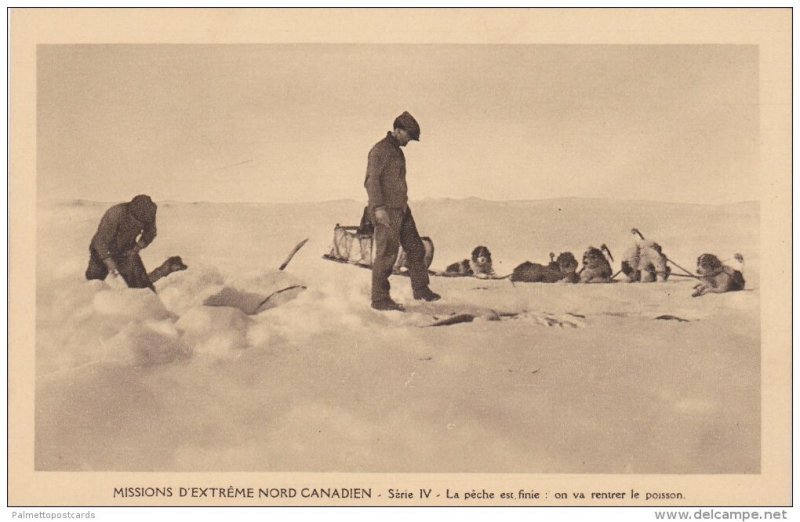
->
86;194;157;292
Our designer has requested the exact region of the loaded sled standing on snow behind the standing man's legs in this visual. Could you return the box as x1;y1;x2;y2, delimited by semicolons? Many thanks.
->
322;208;433;273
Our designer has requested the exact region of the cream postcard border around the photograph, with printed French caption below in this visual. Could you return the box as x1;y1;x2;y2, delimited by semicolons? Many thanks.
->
8;9;792;506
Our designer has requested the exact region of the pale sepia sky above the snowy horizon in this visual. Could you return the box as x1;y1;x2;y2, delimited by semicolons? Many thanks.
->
37;44;759;203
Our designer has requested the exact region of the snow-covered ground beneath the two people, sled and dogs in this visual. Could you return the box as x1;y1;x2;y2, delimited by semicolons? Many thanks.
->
35;200;760;473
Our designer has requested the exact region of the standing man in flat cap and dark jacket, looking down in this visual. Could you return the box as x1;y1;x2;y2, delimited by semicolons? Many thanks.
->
364;112;441;310
